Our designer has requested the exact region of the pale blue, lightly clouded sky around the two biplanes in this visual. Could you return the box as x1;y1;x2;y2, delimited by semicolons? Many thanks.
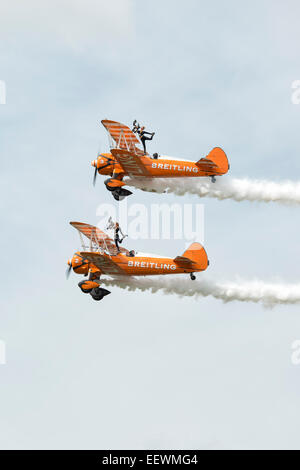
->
0;0;300;449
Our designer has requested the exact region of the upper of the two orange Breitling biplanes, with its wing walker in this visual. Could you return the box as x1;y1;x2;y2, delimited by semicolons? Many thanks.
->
92;119;229;201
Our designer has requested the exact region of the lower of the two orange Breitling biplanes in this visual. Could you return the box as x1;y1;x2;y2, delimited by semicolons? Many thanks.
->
67;222;209;300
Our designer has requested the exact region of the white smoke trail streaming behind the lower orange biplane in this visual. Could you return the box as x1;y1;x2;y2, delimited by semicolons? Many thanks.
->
101;276;300;307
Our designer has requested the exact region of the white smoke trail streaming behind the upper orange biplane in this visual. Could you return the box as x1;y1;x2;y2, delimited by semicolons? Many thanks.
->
126;176;300;204
